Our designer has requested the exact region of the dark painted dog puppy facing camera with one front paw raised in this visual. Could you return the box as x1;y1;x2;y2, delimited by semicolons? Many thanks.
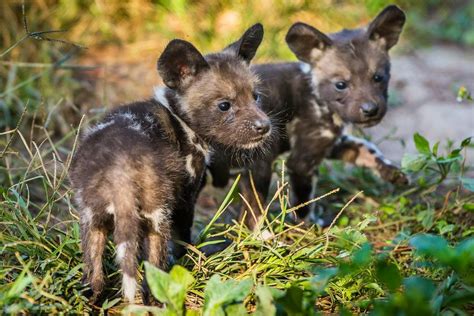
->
210;5;406;228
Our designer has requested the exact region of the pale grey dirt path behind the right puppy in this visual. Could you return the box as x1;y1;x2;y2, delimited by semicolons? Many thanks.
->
367;46;474;165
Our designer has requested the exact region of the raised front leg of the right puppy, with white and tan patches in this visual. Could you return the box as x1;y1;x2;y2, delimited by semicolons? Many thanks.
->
329;135;408;185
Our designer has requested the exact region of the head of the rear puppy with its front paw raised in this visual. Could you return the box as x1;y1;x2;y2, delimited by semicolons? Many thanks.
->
286;5;405;126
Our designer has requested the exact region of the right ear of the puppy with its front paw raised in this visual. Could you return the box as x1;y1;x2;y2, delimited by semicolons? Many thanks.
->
367;5;406;50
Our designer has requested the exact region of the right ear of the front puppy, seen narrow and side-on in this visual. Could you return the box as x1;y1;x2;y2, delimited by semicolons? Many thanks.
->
224;23;263;64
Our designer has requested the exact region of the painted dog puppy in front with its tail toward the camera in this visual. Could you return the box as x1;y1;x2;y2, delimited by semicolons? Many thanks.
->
70;24;271;302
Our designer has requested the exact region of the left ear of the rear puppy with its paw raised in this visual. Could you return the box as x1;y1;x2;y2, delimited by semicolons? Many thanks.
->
286;22;332;64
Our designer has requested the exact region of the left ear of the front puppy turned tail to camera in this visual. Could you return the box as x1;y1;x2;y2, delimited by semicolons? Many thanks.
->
158;39;209;90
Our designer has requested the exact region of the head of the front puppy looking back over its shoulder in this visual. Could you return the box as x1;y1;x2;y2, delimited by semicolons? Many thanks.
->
158;24;271;148
